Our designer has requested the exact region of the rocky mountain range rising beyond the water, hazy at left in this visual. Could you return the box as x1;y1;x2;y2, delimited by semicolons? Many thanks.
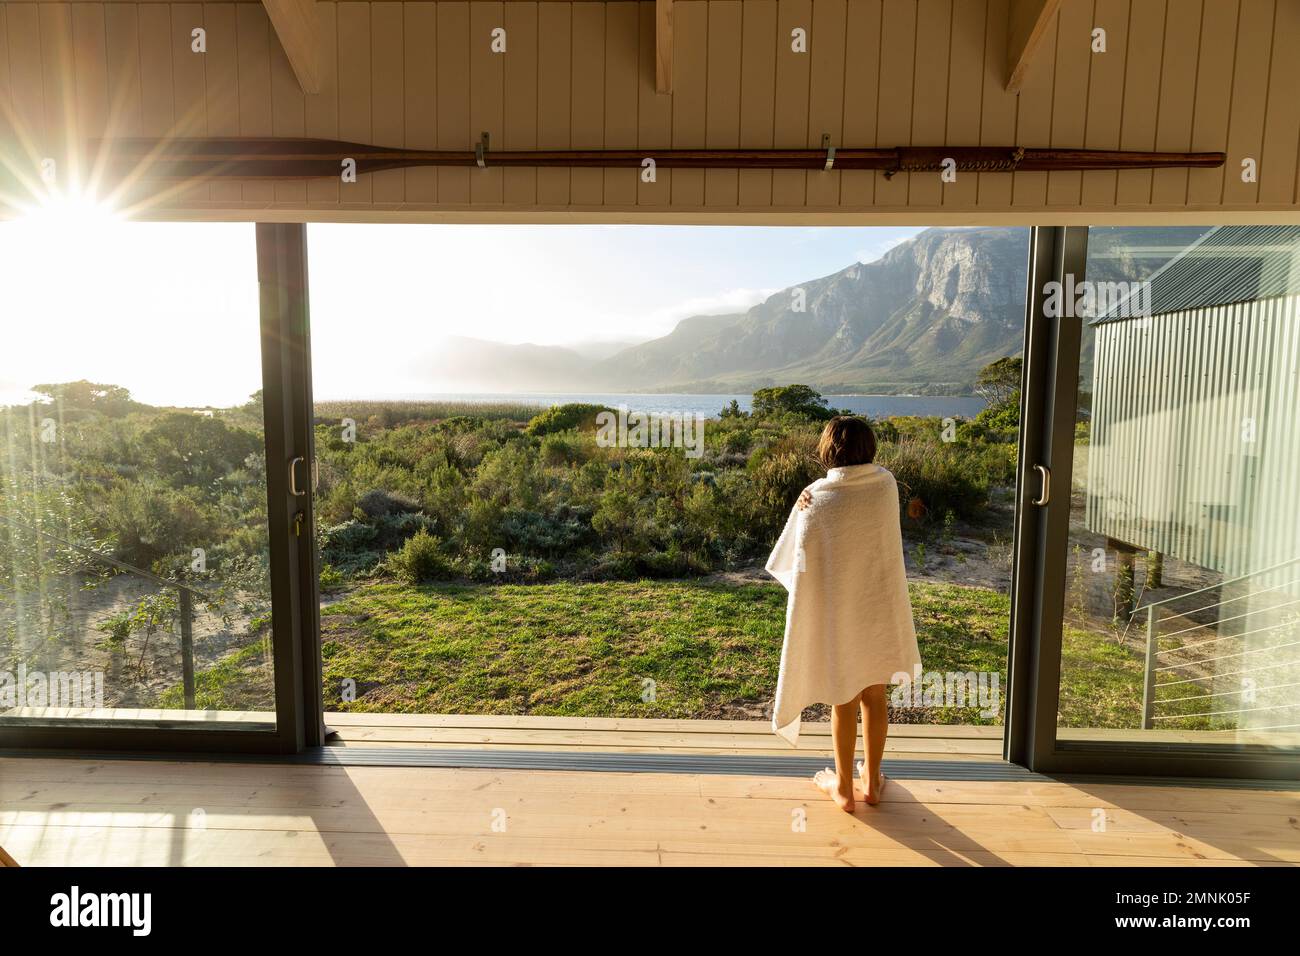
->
425;226;1208;393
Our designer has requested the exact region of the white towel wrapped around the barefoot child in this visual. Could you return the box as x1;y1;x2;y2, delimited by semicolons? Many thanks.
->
767;464;920;744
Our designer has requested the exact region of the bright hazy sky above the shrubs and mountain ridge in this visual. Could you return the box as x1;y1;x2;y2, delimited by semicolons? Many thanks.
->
0;200;919;406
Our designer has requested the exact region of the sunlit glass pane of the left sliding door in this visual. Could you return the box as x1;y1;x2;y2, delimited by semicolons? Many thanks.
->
0;210;276;739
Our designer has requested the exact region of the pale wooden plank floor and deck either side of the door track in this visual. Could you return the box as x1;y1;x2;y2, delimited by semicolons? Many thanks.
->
0;714;1300;866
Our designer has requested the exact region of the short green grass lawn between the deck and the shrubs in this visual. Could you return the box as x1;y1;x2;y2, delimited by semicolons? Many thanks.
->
312;580;1141;727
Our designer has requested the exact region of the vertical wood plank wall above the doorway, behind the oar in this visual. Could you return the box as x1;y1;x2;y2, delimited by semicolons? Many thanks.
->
0;0;1300;222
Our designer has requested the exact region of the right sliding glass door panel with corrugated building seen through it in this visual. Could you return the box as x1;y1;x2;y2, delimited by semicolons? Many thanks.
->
1026;226;1300;777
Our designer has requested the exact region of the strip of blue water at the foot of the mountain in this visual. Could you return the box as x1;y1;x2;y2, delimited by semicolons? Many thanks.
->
374;392;985;419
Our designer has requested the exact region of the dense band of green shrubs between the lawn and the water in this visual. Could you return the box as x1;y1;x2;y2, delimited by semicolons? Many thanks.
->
0;382;1029;592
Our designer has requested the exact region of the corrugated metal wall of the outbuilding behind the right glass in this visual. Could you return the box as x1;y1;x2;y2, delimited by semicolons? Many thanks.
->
1086;295;1300;584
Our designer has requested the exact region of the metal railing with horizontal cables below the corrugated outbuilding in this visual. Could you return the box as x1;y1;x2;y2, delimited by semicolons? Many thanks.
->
1130;557;1300;730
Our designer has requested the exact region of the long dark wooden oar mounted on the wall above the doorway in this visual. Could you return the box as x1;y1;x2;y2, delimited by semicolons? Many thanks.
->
91;137;1225;179
